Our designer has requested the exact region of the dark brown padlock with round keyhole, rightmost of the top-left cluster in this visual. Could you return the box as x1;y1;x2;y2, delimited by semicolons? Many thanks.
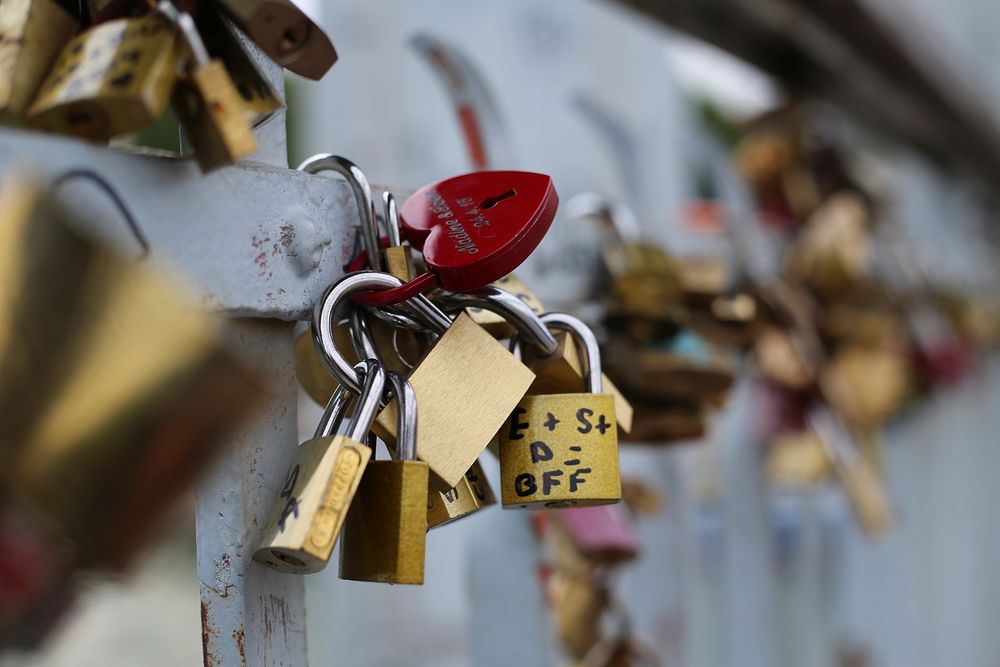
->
211;0;337;80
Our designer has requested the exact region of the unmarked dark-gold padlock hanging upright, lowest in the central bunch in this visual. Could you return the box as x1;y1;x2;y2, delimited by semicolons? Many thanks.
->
340;373;430;584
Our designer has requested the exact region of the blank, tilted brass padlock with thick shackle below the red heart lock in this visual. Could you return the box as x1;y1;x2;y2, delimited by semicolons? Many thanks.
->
312;272;535;490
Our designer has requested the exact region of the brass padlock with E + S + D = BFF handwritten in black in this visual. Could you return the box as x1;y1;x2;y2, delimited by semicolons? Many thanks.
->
499;313;621;508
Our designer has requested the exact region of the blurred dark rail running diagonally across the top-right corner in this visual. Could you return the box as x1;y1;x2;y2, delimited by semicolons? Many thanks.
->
604;0;1000;185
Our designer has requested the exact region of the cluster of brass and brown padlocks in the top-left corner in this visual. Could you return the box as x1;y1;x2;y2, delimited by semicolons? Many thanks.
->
0;0;337;171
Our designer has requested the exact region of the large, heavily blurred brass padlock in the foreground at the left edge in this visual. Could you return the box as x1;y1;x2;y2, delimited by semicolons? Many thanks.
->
0;177;263;569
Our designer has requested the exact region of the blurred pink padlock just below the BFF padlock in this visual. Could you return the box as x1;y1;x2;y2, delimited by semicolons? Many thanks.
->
552;505;639;563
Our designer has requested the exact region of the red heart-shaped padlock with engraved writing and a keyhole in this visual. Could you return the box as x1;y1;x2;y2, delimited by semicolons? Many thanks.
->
356;171;559;305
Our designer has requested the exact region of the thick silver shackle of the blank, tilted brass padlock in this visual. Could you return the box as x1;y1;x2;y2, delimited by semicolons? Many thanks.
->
312;271;451;393
